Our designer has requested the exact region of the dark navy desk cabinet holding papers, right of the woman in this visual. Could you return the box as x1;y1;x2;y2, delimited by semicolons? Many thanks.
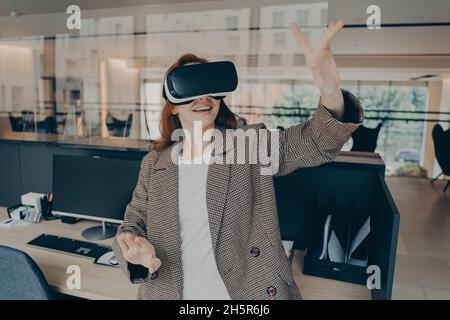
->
274;158;400;299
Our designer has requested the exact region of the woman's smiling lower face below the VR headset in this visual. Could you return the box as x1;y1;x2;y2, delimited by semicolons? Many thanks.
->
172;97;220;129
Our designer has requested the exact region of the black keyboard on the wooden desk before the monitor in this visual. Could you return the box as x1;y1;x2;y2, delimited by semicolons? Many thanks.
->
27;233;112;259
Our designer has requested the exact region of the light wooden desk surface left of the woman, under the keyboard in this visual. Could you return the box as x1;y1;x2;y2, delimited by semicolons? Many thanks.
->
0;207;138;299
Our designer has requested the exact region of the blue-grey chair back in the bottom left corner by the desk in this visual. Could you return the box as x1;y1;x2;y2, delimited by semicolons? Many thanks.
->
0;246;52;300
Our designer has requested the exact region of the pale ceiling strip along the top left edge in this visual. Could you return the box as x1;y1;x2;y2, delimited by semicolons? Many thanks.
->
0;0;211;16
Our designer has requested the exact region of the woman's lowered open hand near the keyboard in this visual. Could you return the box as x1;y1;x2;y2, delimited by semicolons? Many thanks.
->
117;232;161;273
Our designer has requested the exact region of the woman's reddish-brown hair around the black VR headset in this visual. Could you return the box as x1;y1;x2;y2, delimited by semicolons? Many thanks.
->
153;53;237;151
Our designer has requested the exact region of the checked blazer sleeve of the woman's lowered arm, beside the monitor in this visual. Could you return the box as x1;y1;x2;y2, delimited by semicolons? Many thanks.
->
113;154;151;283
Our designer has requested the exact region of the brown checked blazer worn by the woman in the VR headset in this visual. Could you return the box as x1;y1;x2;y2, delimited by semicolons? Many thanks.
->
113;90;363;300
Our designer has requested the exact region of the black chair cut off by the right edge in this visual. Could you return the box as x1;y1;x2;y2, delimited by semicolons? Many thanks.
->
431;123;450;192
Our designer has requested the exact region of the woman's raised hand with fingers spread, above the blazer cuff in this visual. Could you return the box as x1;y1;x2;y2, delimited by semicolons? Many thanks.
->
290;20;344;117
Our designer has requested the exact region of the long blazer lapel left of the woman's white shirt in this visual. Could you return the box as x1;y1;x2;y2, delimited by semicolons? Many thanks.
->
152;143;183;299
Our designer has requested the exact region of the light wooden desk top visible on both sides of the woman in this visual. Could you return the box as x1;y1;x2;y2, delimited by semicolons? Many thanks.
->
0;207;370;300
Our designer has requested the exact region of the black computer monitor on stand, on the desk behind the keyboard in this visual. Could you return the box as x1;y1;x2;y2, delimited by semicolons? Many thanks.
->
52;155;140;240
